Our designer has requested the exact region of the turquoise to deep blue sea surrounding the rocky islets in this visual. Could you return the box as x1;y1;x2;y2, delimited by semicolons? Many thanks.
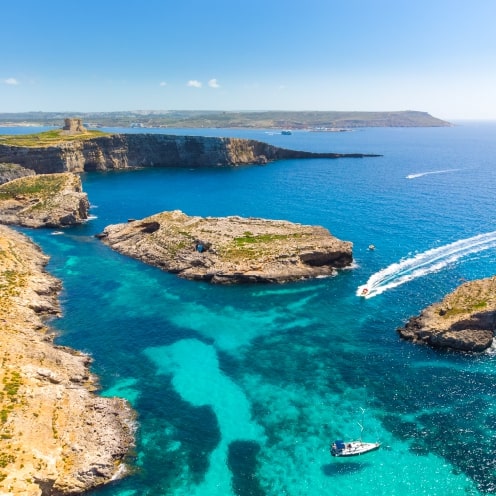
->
1;121;496;496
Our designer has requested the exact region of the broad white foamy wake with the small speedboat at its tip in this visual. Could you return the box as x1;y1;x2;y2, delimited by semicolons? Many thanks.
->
356;231;496;298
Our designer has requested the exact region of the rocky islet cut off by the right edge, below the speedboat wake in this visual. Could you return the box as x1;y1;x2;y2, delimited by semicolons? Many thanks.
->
398;276;496;352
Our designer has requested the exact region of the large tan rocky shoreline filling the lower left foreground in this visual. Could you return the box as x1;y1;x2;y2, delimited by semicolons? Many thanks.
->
0;226;135;496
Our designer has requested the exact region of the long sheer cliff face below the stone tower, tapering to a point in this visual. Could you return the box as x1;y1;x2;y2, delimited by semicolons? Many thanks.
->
0;134;377;174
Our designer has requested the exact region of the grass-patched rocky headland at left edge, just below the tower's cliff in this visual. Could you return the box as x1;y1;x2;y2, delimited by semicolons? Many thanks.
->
0;173;89;227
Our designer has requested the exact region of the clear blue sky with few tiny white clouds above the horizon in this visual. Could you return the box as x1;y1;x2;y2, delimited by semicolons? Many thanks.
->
0;0;496;120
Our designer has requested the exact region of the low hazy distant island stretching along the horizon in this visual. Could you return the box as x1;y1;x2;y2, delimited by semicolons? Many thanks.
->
0;110;451;131
